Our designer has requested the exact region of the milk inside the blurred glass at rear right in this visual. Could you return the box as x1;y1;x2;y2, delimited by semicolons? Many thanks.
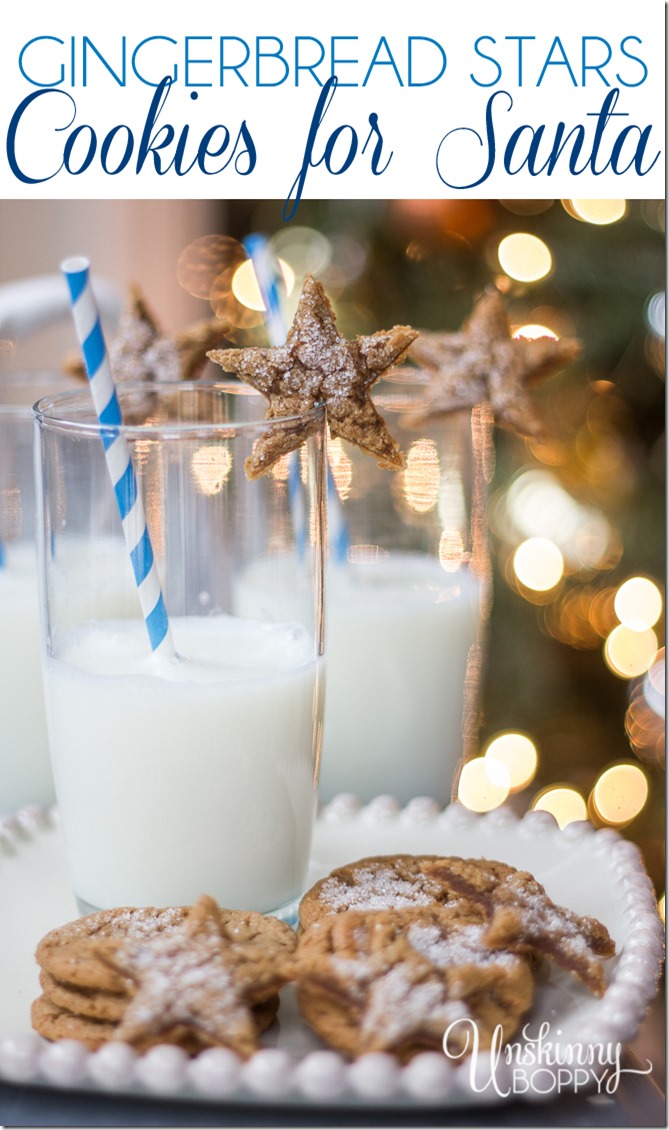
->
237;553;480;803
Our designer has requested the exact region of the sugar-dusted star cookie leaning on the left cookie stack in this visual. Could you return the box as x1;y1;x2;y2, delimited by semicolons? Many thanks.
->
96;895;292;1055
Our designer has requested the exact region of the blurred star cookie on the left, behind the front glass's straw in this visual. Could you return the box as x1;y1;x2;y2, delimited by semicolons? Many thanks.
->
63;286;227;384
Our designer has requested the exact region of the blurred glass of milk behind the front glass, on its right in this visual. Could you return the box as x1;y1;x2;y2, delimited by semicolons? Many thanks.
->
241;376;492;803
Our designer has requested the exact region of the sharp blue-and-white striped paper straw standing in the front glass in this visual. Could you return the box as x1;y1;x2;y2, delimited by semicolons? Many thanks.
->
61;258;175;657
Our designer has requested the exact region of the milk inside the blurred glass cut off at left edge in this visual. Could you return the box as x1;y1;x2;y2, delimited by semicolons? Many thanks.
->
0;542;54;812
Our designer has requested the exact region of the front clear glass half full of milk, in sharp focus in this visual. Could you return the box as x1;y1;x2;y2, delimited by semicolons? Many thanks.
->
35;384;324;914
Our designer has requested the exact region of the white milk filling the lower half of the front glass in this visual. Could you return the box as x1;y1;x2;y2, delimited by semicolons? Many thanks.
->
45;616;322;911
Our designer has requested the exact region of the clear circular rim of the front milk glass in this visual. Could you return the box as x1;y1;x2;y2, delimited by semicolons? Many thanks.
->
32;381;325;440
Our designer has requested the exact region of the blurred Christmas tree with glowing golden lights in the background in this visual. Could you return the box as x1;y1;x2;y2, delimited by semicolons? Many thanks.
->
214;192;666;896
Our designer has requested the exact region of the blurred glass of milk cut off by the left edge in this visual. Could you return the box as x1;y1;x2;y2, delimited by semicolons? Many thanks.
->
0;371;79;814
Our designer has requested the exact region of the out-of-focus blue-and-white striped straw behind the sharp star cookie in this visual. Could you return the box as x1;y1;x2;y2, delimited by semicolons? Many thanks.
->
243;233;349;562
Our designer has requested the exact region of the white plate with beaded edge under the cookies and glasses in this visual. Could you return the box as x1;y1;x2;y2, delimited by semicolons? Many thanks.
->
0;797;663;1106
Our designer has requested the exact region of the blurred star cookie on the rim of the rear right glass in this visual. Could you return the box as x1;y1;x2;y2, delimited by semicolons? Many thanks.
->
409;289;581;437
